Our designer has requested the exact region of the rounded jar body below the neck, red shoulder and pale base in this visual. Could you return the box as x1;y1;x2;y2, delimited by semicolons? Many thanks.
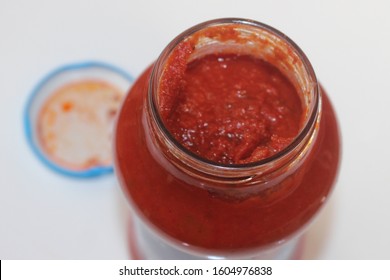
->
115;20;340;258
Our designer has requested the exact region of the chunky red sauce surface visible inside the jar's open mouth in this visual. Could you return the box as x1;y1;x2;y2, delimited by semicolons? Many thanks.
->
161;54;302;164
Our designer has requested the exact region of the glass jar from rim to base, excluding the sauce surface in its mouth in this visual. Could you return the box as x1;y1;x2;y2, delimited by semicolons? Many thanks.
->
115;18;339;259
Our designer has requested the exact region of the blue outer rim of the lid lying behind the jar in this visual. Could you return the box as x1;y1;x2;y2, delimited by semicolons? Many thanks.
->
23;61;134;178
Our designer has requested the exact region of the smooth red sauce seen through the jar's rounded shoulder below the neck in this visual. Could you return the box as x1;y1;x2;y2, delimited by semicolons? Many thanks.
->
116;66;339;250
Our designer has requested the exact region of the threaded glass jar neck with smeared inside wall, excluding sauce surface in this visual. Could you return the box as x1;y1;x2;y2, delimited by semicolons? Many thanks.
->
143;18;321;188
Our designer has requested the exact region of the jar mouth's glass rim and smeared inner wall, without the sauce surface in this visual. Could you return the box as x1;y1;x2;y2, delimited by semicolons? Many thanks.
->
148;18;321;174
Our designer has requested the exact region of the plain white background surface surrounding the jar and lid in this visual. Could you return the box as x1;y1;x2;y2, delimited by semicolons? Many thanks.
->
0;0;390;259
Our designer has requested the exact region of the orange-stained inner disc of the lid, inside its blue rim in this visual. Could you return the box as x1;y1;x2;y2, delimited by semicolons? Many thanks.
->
37;79;124;170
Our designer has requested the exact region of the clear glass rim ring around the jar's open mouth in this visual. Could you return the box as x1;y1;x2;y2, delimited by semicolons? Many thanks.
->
147;18;321;171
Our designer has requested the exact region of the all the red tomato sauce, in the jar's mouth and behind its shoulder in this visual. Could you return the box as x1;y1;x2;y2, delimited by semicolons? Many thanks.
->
115;21;340;252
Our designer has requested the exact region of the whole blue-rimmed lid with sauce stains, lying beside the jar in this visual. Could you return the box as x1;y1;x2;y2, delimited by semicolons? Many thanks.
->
24;62;133;177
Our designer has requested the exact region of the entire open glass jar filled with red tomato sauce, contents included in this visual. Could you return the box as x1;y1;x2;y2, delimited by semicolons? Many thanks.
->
115;18;340;259
